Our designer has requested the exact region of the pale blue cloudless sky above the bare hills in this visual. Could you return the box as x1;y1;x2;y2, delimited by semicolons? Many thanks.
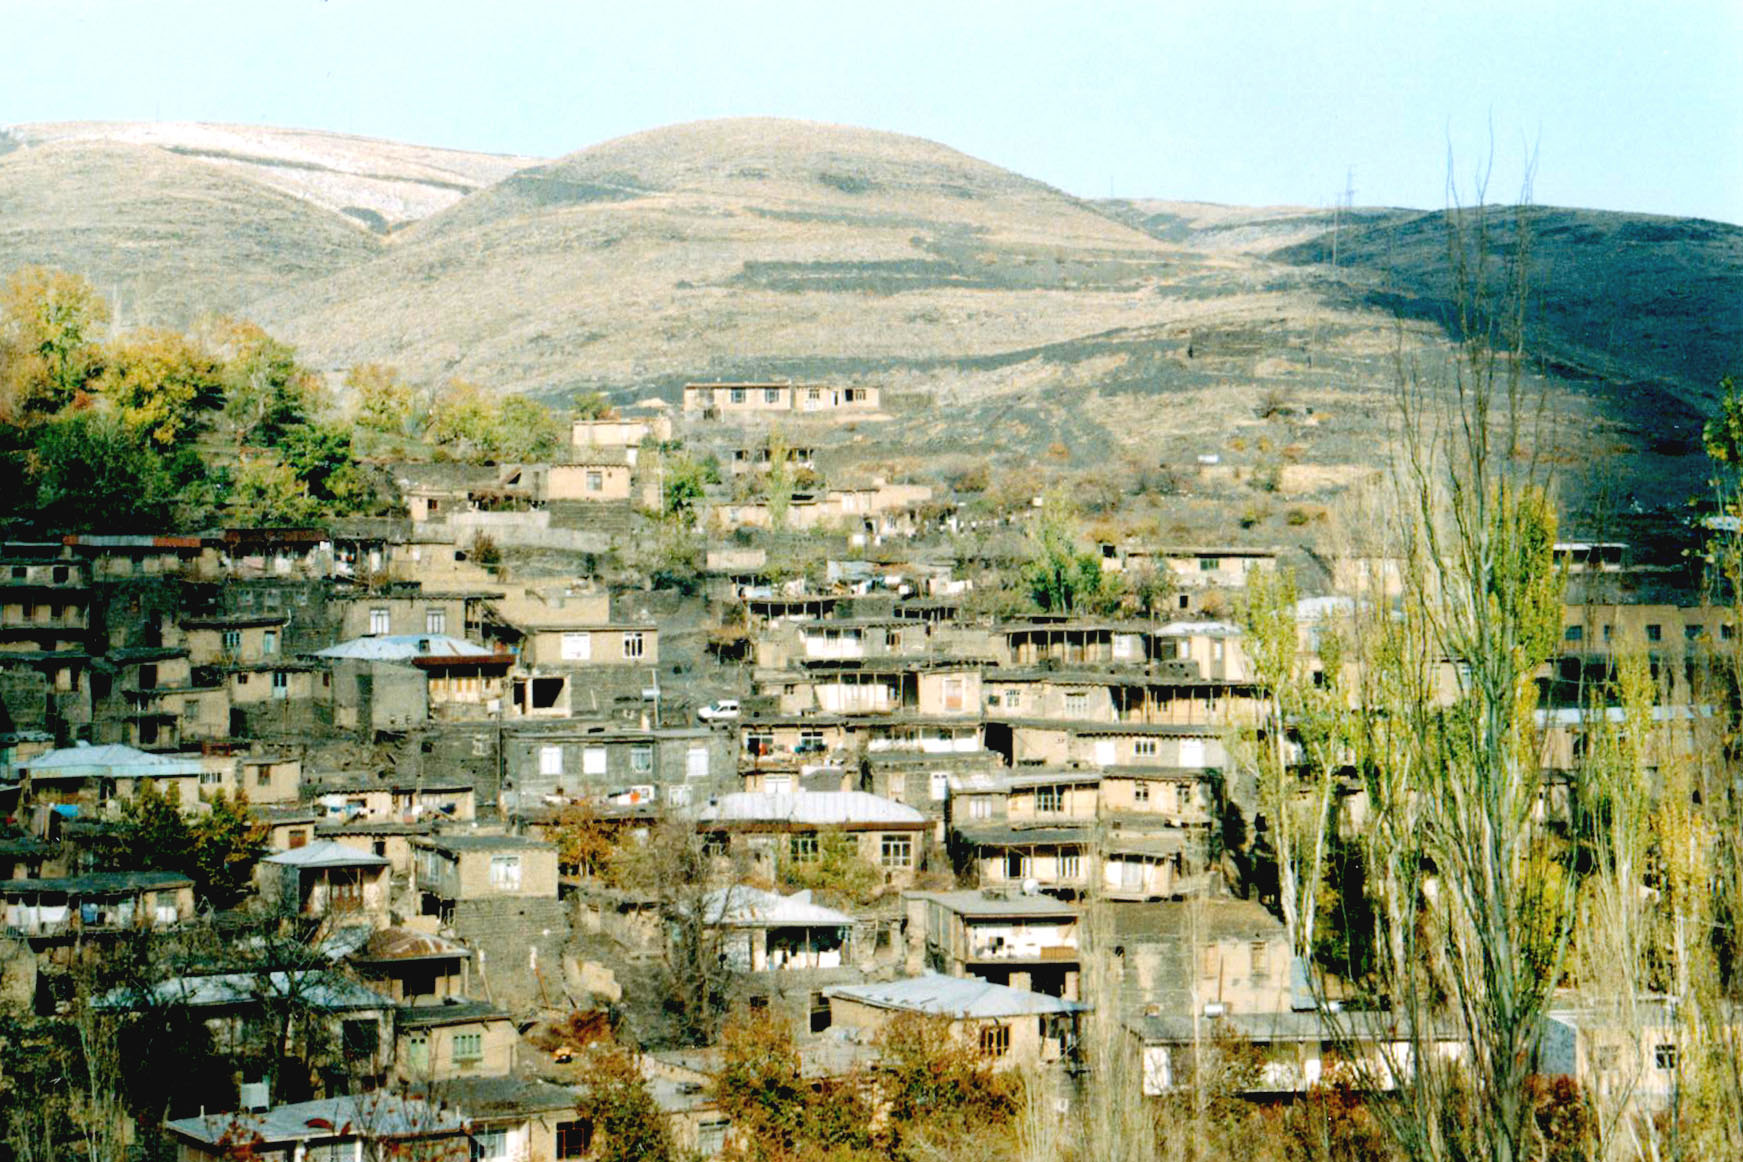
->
10;0;1743;223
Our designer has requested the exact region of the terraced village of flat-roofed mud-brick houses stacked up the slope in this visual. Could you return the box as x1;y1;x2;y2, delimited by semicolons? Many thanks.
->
0;348;1736;1162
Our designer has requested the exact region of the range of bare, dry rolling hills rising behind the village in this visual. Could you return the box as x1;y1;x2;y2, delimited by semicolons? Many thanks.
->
0;120;1743;524
